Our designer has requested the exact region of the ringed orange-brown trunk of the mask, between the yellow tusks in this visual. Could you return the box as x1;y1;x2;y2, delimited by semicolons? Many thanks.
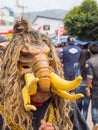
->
33;54;50;91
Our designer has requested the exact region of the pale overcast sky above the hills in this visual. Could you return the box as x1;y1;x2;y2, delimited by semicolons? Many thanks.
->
0;0;98;12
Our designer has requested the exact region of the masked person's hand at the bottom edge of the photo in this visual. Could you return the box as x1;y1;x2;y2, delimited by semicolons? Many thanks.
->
39;120;55;130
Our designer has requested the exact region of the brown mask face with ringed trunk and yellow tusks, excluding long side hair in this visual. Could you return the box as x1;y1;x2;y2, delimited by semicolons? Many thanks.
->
12;18;83;111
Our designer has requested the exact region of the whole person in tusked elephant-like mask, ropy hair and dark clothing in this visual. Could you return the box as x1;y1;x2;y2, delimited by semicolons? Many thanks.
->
0;19;89;130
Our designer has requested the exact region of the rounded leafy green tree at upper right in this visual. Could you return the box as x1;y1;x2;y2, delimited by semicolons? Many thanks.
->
64;0;98;41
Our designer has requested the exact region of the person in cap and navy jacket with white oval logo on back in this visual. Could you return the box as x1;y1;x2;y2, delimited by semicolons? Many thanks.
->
62;37;81;80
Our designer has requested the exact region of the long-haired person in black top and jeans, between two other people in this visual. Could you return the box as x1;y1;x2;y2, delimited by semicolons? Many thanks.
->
74;49;90;120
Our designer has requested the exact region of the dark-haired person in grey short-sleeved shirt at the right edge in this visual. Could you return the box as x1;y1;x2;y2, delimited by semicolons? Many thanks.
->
86;43;98;130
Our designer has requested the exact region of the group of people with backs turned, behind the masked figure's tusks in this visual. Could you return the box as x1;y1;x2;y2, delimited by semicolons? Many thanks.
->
57;37;98;130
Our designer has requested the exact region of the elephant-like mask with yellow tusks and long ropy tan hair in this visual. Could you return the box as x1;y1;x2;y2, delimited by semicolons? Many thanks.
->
0;19;83;130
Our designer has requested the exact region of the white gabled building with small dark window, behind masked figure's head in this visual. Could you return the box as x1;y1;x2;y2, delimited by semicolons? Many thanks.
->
32;16;64;35
